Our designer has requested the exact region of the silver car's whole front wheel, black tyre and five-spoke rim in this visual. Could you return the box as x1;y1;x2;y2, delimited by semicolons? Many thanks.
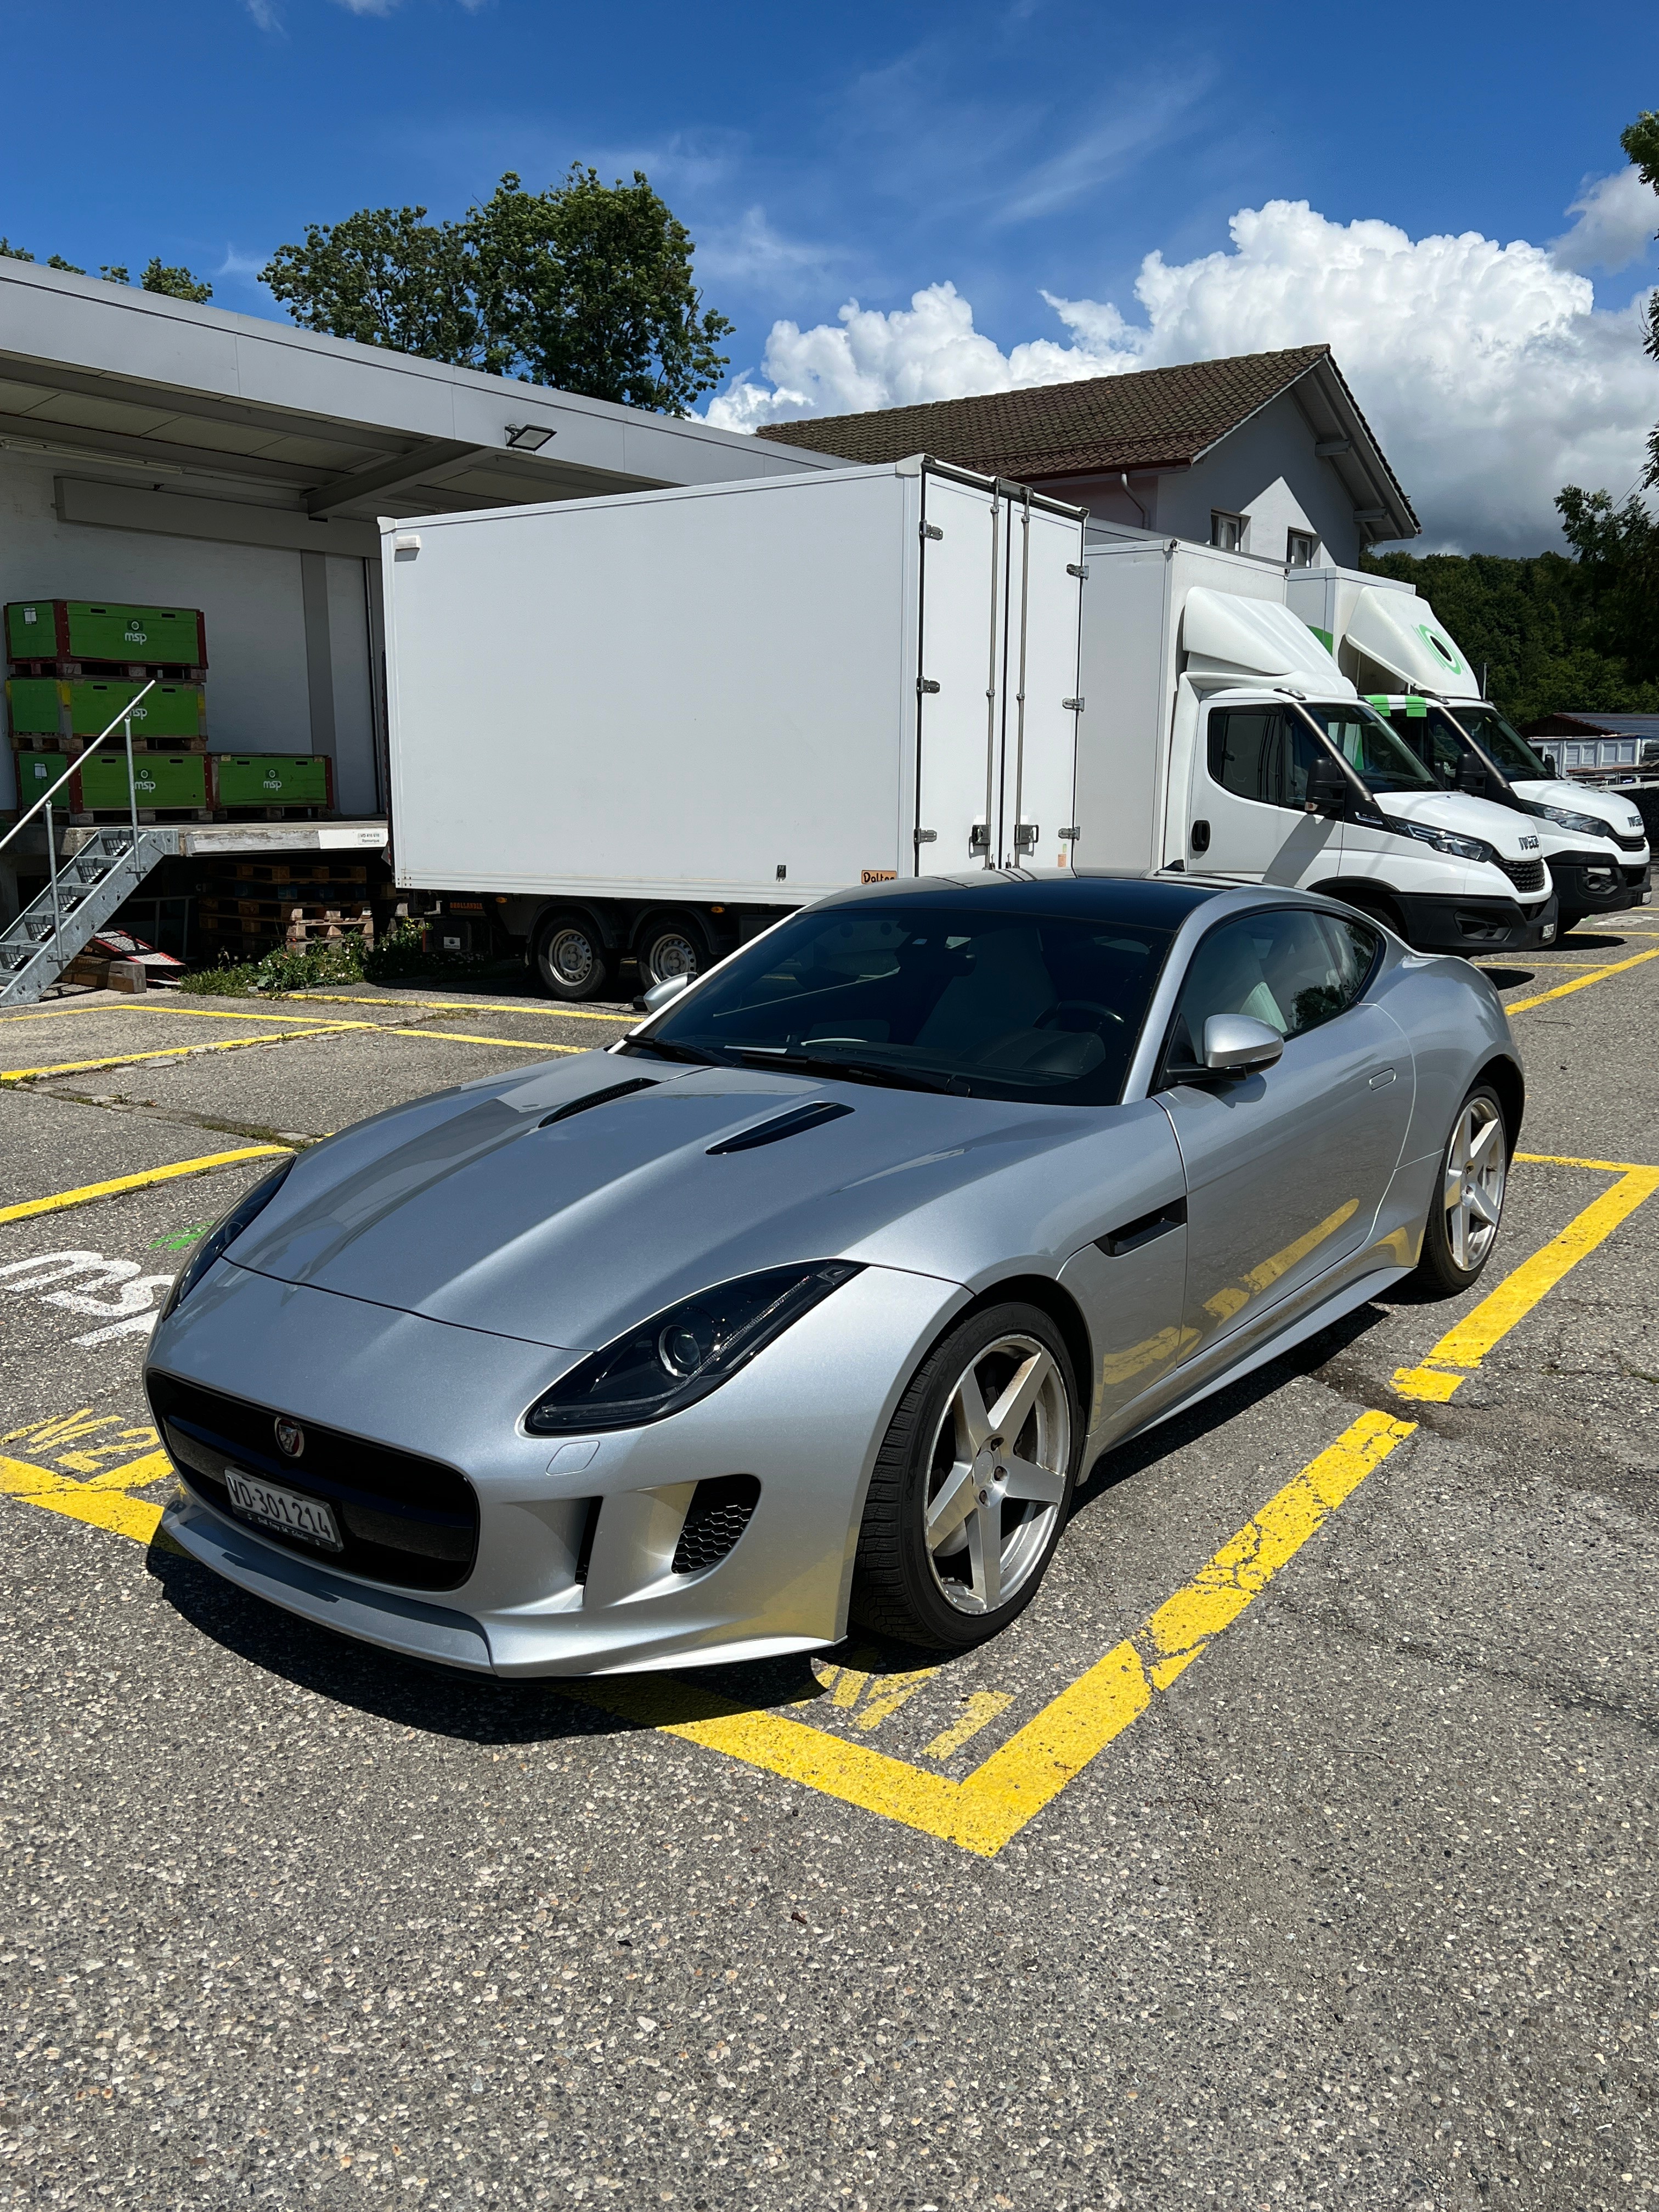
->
851;1305;1084;1652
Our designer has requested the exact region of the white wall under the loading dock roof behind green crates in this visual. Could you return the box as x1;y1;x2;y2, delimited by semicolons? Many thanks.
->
0;452;378;814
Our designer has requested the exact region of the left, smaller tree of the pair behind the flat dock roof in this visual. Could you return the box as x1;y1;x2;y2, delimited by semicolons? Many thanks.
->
259;208;482;369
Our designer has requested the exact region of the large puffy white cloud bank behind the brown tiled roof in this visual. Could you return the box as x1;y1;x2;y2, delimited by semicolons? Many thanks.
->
708;199;1659;551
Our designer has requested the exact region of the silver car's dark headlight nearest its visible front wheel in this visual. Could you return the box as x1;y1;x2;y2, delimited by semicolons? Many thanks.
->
524;1259;860;1436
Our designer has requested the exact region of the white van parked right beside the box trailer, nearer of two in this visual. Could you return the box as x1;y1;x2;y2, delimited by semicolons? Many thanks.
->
1073;539;1555;953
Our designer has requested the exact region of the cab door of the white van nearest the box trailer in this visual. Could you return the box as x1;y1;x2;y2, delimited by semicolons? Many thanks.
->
1188;701;1342;885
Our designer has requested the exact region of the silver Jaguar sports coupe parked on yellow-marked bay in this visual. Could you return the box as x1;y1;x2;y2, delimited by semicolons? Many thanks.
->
146;874;1522;1674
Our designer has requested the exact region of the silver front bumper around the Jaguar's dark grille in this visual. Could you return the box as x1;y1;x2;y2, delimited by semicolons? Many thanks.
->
150;1263;967;1674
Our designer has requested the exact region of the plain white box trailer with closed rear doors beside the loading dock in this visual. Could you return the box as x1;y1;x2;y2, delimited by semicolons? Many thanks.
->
383;458;1084;1000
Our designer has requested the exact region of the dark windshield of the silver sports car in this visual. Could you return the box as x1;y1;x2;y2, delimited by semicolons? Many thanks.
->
624;900;1170;1106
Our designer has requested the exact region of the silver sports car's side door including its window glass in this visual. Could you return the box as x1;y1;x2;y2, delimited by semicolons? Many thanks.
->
1159;907;1413;1358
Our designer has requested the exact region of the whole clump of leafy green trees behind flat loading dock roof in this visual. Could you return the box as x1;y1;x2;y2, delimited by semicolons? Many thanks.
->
261;163;732;414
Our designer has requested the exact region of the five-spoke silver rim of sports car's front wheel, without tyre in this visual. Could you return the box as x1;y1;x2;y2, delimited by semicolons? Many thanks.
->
924;1336;1070;1612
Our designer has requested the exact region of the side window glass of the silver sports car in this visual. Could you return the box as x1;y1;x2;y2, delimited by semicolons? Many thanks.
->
1166;907;1378;1066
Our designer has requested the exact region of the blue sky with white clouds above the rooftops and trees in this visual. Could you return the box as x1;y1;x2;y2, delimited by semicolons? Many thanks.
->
0;0;1659;544
